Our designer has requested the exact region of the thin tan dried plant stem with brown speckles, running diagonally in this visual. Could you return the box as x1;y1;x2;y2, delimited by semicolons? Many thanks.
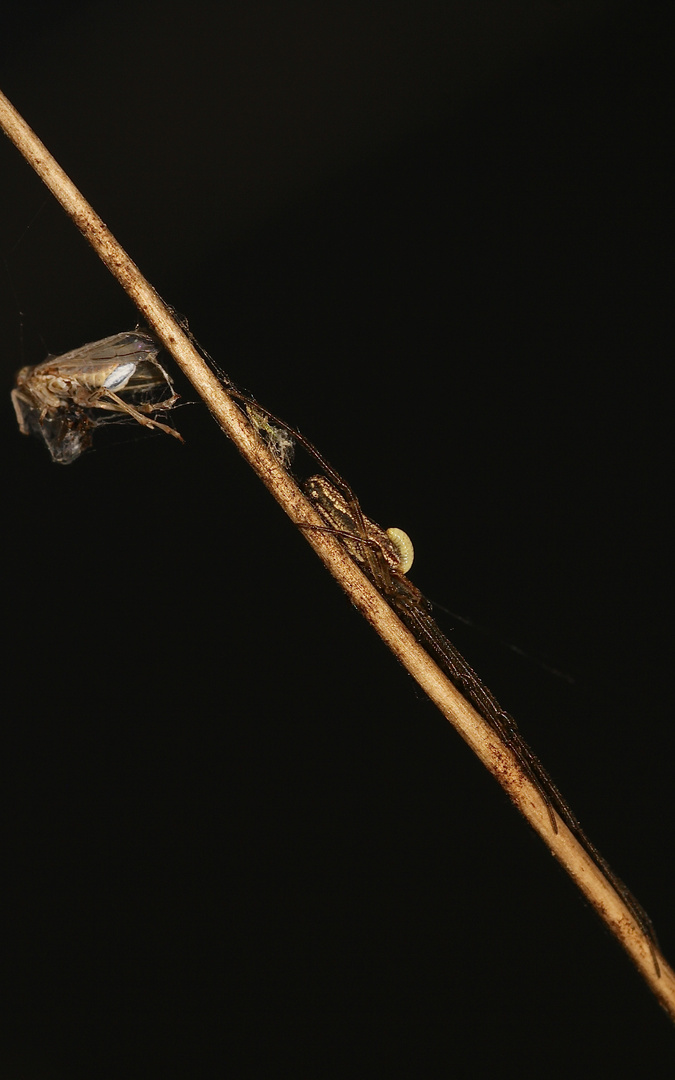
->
0;86;675;1020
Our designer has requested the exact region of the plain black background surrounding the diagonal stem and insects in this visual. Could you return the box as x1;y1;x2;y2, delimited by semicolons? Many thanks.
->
0;0;675;1077
